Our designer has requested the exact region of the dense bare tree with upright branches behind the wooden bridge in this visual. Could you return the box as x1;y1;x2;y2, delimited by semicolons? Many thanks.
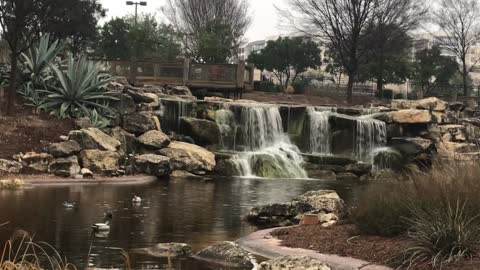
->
163;0;251;62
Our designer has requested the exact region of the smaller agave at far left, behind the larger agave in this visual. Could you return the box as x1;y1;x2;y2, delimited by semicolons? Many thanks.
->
22;34;63;84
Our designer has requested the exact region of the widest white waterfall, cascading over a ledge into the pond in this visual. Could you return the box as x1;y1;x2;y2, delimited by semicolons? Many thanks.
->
221;104;308;178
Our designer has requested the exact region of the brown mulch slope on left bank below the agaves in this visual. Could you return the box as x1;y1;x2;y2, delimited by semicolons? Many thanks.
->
0;110;74;159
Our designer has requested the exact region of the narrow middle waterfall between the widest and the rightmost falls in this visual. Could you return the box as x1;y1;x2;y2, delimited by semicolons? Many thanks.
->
307;107;331;155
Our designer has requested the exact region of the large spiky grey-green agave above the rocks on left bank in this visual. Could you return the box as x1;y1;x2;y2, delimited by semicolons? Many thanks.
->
40;56;116;118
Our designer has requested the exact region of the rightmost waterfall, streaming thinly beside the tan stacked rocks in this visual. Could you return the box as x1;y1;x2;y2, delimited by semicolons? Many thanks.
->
354;116;387;163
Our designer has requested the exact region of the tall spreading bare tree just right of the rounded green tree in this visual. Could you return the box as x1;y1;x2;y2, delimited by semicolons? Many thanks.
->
289;0;378;103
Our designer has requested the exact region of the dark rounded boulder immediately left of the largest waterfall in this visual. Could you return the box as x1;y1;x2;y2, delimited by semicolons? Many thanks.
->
180;117;220;145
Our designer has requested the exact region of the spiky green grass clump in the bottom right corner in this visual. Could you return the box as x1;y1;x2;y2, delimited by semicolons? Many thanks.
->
400;201;480;269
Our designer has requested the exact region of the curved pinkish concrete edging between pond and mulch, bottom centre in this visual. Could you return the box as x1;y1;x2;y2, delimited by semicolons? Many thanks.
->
236;227;393;270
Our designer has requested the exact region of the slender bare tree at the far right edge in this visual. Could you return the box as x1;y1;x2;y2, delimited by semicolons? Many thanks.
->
432;0;480;96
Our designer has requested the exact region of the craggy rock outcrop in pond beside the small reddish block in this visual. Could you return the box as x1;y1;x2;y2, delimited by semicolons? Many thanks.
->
247;190;346;226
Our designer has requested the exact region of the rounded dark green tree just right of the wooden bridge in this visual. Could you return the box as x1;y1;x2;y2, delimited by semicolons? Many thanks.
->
247;37;322;87
